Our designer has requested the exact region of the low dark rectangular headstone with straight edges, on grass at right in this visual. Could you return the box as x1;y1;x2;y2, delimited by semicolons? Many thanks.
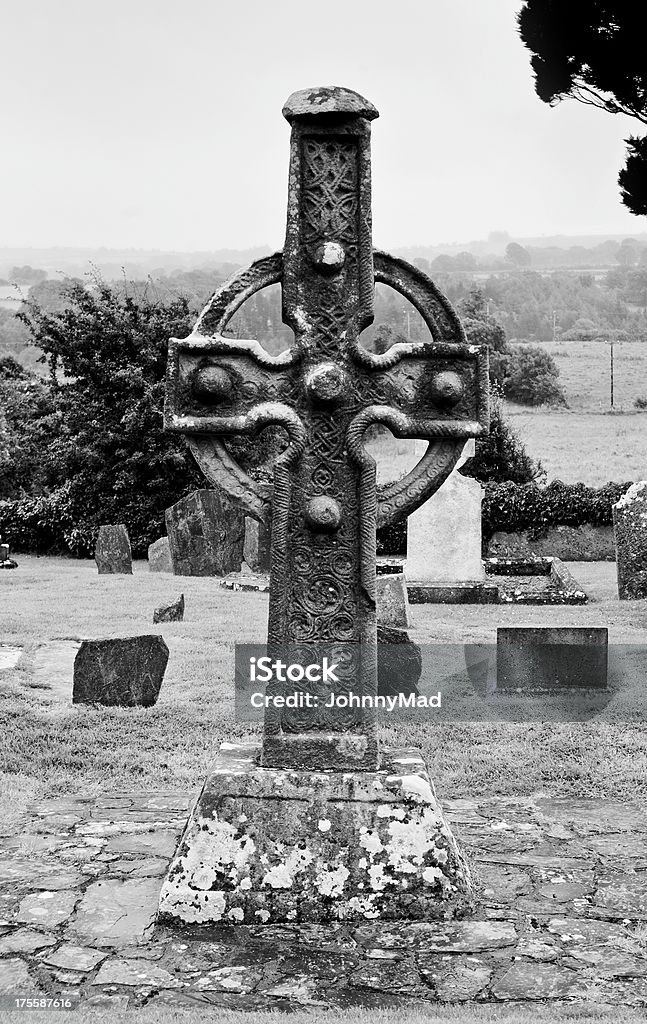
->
497;626;608;691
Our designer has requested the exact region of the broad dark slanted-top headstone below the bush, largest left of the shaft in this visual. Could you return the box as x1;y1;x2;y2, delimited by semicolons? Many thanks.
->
166;488;245;577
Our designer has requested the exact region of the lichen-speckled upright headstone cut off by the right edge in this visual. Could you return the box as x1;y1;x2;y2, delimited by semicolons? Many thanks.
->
612;480;647;601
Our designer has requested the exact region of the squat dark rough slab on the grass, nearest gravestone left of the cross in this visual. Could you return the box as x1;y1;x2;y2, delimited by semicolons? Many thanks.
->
72;635;169;708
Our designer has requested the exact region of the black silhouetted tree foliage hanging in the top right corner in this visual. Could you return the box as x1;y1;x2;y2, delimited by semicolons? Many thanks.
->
518;0;647;215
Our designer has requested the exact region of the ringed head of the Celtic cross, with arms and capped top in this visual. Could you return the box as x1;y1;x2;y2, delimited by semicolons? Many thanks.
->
165;88;488;531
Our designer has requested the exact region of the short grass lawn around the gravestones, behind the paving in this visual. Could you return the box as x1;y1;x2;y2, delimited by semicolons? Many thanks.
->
0;556;647;815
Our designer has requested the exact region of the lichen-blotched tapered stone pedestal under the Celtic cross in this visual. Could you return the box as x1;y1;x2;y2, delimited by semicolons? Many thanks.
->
159;743;471;924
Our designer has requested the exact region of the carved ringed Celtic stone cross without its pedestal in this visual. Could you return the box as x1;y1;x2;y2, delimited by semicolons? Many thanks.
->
165;88;487;771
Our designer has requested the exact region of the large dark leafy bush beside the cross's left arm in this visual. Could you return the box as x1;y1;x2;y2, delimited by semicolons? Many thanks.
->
20;282;203;554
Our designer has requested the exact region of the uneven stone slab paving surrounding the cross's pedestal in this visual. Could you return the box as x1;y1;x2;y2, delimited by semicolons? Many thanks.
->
0;793;647;1010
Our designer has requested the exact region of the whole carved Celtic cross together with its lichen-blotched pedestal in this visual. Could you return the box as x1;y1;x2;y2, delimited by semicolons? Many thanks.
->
160;88;487;924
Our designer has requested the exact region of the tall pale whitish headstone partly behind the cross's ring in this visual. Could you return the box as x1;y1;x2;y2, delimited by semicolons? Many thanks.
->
405;439;485;585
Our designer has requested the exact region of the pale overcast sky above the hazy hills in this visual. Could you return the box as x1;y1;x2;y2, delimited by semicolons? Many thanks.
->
0;0;647;250
